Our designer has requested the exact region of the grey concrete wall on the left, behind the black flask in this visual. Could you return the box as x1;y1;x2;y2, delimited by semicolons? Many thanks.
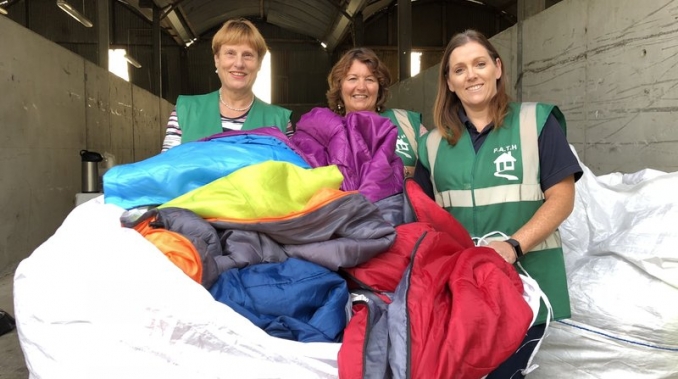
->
0;16;172;272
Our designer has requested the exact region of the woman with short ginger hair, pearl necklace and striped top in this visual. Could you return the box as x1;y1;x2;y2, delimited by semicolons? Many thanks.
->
162;19;292;151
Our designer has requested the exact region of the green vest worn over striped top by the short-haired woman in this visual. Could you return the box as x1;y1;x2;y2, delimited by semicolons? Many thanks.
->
176;91;292;143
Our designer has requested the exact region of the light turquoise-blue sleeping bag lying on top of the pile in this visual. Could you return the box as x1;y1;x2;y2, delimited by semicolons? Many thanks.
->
103;127;310;209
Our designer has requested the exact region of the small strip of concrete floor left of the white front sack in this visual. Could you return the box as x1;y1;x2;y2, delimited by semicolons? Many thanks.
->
0;266;28;379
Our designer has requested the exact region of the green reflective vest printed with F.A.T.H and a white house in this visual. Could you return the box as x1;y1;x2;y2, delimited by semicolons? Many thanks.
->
419;103;570;324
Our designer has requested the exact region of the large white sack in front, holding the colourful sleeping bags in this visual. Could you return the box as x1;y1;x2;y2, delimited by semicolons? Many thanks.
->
14;198;339;379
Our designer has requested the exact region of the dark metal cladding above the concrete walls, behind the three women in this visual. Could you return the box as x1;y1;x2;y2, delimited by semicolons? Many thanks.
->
9;0;512;120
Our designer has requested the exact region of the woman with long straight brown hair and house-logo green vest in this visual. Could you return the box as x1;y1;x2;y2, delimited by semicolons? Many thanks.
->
414;30;582;379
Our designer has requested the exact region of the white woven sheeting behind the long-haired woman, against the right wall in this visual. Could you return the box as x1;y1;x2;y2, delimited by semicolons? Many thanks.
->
530;168;678;379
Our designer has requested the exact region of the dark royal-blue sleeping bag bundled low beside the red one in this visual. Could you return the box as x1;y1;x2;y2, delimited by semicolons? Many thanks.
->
210;258;349;342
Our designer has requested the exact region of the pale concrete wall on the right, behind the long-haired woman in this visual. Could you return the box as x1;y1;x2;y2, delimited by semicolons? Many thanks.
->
389;0;678;175
